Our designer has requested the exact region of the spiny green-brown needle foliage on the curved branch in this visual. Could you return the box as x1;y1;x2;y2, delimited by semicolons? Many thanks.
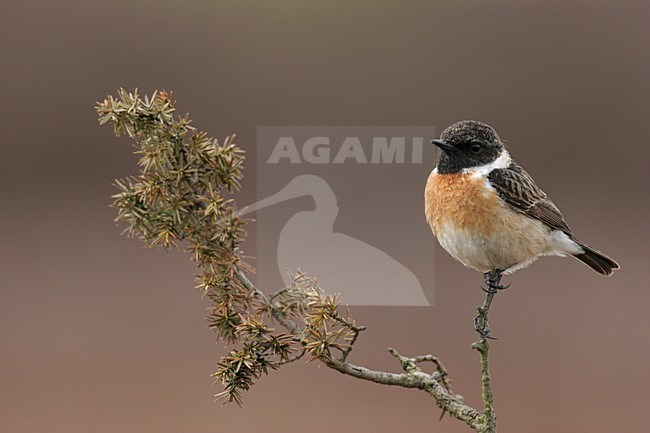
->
96;89;362;404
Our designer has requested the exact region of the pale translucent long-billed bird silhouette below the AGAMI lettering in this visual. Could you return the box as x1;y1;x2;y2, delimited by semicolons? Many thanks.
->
241;174;431;306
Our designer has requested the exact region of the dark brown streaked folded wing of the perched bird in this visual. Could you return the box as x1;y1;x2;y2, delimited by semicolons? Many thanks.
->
488;162;571;235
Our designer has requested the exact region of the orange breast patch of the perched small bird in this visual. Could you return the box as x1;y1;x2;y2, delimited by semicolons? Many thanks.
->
424;173;503;236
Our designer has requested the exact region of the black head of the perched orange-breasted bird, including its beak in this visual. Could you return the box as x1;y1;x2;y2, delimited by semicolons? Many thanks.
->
431;120;505;174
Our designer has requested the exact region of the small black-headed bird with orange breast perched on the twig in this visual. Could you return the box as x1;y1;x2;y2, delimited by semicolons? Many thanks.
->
424;120;620;338
